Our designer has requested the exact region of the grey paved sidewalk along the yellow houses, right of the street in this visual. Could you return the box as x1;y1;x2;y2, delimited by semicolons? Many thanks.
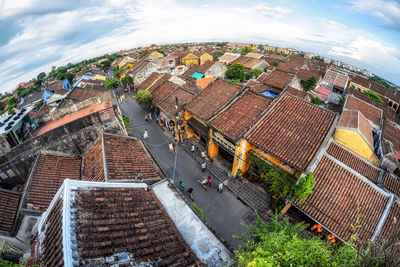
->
182;139;273;215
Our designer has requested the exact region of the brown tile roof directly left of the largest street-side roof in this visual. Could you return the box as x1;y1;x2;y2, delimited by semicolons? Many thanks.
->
211;91;272;141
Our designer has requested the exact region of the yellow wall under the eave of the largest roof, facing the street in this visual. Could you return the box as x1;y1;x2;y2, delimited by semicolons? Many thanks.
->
232;138;303;178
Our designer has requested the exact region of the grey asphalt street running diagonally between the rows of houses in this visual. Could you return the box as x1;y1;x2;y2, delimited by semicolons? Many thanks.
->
121;92;254;249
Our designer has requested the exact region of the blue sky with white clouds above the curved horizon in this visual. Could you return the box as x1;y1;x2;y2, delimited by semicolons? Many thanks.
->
0;0;400;92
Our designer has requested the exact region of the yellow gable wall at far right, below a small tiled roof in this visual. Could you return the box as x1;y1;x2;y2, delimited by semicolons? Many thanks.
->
333;129;380;167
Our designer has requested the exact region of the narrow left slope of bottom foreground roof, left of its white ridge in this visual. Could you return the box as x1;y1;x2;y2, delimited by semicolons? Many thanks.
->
40;198;64;267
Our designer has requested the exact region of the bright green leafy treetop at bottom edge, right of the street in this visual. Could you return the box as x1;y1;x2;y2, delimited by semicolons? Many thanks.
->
235;214;359;267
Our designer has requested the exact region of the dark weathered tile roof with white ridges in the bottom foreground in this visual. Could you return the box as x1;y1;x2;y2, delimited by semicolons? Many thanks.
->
40;183;204;266
